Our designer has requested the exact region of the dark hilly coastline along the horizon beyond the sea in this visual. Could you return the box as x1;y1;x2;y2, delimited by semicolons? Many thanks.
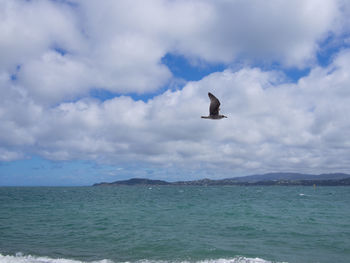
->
93;173;350;186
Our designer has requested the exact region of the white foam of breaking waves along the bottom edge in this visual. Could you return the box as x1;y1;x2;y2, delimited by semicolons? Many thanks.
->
0;253;284;263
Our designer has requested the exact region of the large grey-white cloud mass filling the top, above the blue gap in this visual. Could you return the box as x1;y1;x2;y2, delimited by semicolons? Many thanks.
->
0;0;345;104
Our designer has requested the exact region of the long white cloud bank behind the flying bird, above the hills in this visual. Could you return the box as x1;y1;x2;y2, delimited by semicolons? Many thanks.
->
1;48;350;177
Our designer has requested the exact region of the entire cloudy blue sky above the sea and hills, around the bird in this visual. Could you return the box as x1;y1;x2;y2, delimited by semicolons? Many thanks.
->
0;0;350;186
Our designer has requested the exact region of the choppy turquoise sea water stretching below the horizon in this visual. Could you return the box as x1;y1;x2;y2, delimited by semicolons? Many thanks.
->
0;186;350;263
